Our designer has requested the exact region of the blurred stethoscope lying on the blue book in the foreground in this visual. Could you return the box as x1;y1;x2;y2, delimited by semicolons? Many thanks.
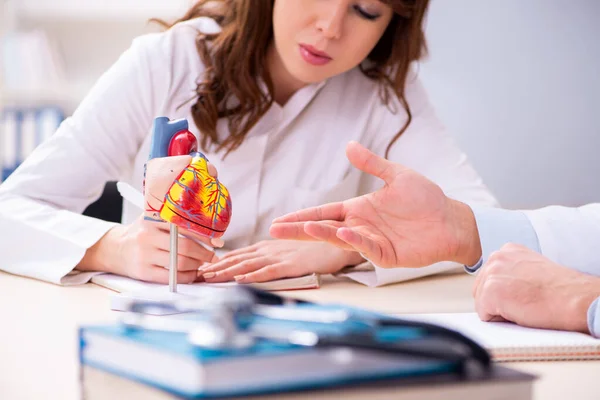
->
121;286;491;376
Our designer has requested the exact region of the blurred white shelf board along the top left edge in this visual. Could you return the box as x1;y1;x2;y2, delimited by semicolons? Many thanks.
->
13;0;192;21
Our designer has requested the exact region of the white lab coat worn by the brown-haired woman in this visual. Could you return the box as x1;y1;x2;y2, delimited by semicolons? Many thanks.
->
0;18;496;285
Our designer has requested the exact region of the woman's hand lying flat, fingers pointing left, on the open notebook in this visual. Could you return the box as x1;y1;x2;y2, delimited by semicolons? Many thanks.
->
200;240;363;283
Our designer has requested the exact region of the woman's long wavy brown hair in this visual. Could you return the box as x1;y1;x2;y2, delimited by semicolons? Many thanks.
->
155;0;429;157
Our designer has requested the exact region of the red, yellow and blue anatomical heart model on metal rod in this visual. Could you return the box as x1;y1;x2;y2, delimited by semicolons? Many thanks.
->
144;117;231;238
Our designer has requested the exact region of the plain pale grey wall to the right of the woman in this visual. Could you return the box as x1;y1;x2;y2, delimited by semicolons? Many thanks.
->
421;0;600;207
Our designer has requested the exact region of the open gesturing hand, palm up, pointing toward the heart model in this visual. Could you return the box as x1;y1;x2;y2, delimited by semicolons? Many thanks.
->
271;142;481;268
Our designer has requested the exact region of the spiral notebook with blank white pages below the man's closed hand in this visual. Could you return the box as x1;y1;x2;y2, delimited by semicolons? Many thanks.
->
398;313;600;362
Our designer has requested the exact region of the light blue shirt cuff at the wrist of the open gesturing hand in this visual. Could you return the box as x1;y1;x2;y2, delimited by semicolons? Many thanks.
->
465;206;540;274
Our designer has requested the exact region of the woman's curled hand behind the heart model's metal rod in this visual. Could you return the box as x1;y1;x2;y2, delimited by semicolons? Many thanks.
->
77;216;223;284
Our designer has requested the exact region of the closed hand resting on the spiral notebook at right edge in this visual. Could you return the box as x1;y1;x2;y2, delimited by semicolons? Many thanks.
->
473;244;600;333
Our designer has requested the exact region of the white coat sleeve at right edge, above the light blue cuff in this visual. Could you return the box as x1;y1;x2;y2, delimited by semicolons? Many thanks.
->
525;203;600;276
